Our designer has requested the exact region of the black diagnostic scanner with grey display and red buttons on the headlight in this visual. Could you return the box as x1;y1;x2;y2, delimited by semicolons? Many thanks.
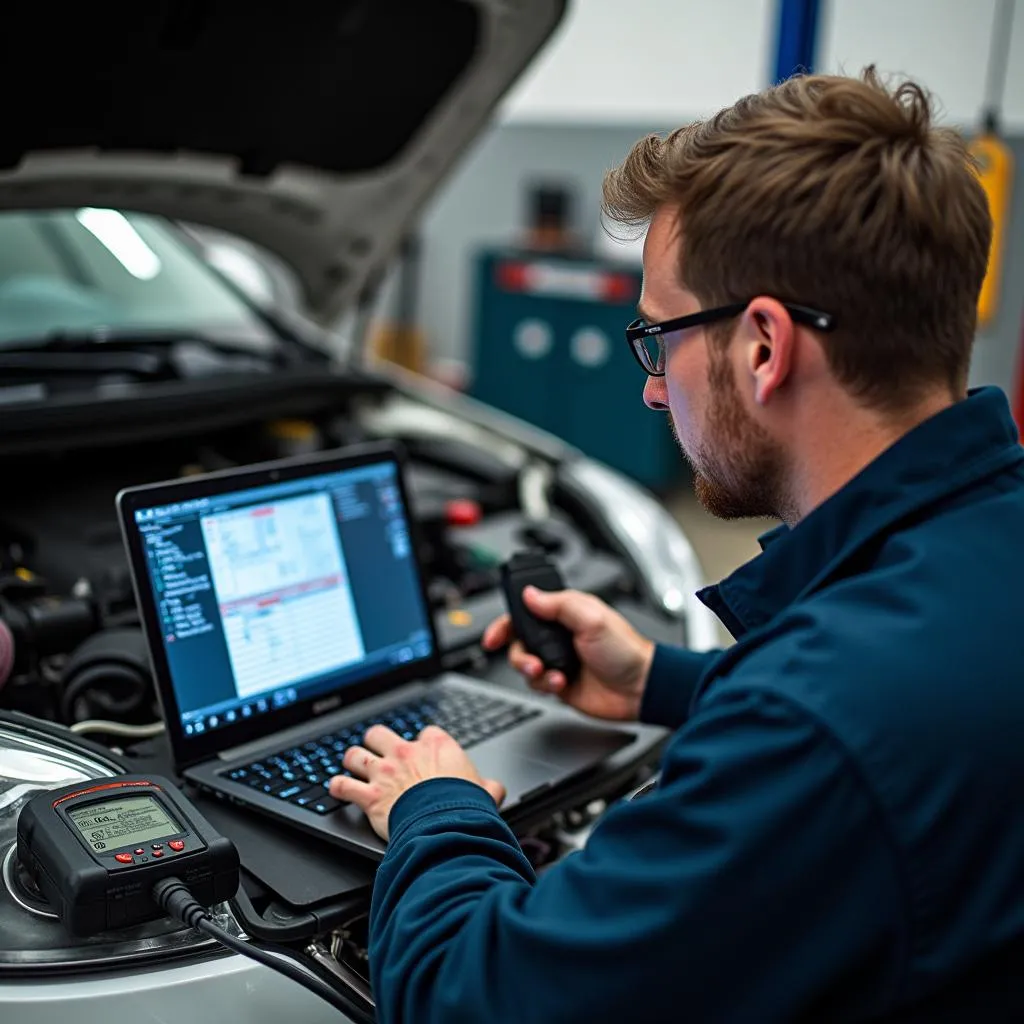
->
17;775;239;936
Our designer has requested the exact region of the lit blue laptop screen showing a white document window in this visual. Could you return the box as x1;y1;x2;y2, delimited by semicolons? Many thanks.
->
126;460;433;739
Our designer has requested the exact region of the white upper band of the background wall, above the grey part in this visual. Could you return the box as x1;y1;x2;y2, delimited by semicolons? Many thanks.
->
502;0;1024;130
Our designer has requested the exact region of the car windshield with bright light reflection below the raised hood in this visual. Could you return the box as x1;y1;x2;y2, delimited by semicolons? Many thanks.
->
0;208;276;351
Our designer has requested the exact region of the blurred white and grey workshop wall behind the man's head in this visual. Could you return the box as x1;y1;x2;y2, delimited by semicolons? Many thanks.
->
420;0;1024;388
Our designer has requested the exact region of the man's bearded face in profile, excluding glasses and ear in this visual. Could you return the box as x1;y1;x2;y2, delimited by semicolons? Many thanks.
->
640;208;784;519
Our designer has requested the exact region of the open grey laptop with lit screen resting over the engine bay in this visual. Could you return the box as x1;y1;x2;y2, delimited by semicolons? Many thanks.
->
117;443;649;858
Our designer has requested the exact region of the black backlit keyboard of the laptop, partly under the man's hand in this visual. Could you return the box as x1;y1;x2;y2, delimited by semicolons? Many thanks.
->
224;688;541;814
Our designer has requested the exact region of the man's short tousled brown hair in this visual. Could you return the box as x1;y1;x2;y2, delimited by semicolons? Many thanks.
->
604;68;991;409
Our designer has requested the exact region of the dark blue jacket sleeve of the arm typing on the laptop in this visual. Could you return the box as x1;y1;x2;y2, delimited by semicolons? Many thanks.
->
370;693;905;1024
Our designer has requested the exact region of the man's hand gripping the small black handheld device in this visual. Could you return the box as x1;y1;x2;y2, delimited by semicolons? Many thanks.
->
483;587;654;722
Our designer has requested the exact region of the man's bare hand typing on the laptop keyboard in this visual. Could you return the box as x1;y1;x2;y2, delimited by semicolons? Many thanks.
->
331;725;505;840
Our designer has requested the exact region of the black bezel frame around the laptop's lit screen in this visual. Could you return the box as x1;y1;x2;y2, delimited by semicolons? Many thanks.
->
116;441;441;769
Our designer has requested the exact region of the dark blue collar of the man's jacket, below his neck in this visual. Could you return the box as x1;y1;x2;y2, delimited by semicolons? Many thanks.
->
697;387;1024;638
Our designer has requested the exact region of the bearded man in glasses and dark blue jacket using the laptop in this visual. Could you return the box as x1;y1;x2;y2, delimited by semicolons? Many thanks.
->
332;72;1024;1024
